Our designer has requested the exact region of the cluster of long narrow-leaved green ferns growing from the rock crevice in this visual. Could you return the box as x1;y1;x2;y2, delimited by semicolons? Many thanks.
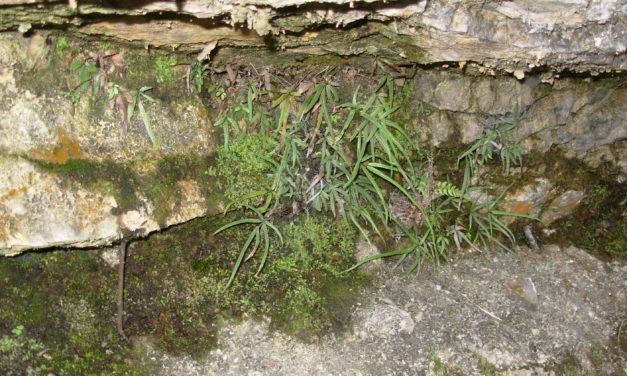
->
209;78;526;286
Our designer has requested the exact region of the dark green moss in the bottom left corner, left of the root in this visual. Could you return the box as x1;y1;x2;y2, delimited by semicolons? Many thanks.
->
0;251;156;375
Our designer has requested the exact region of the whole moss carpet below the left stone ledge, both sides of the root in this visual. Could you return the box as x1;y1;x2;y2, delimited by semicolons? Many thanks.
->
0;210;366;375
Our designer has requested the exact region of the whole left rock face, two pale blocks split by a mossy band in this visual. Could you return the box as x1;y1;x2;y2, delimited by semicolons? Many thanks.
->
0;35;226;255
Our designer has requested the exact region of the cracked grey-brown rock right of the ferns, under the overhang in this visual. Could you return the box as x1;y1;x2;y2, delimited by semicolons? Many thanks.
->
414;70;627;164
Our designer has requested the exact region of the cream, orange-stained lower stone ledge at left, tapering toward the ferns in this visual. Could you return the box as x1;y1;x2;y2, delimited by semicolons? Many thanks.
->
0;156;215;255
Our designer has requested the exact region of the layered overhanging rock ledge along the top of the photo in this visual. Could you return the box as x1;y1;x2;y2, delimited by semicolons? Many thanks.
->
0;0;627;72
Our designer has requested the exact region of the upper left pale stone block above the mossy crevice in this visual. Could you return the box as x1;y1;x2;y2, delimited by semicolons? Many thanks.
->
0;35;214;161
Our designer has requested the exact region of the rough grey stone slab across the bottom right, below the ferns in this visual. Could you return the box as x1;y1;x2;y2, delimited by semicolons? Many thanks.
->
135;246;627;376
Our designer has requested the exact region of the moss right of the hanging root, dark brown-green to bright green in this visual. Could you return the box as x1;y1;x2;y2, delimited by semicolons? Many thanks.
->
110;216;354;355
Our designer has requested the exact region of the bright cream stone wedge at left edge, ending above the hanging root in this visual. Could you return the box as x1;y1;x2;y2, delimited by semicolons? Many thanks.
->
0;157;121;255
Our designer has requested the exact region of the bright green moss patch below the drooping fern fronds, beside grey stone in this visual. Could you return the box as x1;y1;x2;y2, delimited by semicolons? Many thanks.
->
194;215;365;340
